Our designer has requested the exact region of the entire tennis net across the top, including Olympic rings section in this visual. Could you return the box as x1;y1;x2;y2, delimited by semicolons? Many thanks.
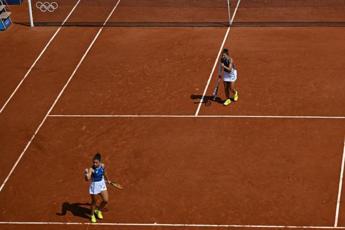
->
26;0;345;27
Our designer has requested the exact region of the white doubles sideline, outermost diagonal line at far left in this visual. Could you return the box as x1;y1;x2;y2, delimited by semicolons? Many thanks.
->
0;0;81;113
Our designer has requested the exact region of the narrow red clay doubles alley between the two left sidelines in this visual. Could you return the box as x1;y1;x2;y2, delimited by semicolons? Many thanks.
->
0;0;118;188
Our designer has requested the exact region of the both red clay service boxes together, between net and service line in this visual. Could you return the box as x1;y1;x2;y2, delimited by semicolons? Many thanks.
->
53;28;345;116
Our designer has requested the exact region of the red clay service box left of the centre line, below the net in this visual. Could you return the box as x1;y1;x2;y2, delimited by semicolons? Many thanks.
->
53;28;225;114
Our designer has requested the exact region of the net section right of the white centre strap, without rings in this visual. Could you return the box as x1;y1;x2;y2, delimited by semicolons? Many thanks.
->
233;0;345;27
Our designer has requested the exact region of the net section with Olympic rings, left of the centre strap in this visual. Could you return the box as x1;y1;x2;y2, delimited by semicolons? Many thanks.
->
31;0;235;27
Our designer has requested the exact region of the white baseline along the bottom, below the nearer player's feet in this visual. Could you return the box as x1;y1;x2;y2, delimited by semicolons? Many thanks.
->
0;221;345;229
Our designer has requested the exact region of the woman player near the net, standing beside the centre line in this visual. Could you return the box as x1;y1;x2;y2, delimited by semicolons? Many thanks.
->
219;48;238;106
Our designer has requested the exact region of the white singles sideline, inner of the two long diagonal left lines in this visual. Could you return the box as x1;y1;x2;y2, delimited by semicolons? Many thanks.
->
0;0;121;192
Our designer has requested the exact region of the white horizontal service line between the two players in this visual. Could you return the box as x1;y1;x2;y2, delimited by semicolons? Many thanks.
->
49;114;345;120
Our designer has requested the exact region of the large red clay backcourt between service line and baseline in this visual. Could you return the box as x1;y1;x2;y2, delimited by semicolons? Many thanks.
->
0;118;344;225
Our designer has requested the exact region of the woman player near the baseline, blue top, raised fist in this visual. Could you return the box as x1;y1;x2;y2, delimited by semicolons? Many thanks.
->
85;153;111;223
